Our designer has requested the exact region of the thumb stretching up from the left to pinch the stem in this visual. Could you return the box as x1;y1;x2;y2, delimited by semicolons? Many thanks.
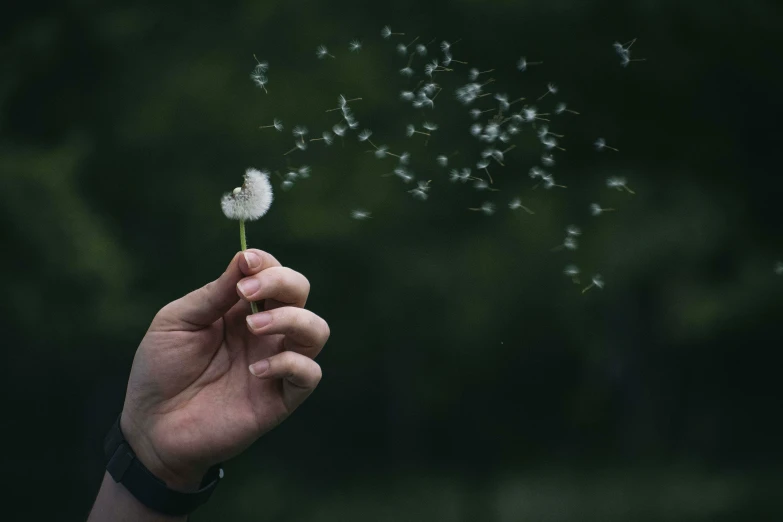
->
153;249;280;329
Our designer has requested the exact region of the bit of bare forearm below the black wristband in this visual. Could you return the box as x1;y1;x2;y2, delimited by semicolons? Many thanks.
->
87;473;187;522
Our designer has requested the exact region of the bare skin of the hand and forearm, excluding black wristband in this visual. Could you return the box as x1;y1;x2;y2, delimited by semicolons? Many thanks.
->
88;249;329;522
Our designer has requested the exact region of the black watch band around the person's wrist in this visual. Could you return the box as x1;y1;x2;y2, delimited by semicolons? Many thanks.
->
103;417;223;516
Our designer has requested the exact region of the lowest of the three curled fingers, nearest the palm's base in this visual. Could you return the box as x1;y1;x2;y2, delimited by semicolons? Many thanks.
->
250;352;321;413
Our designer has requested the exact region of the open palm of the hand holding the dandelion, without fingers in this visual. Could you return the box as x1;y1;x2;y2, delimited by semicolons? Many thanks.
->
129;301;292;474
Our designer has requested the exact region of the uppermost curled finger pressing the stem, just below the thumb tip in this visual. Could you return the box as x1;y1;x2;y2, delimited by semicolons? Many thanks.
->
237;266;310;307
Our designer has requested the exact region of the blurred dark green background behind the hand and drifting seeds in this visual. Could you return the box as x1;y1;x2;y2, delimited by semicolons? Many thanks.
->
0;0;783;522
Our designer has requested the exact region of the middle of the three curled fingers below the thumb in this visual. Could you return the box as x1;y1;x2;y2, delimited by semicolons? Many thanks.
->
247;306;330;357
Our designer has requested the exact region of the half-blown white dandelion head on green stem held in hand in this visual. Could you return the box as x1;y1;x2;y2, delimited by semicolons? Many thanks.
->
220;168;273;313
